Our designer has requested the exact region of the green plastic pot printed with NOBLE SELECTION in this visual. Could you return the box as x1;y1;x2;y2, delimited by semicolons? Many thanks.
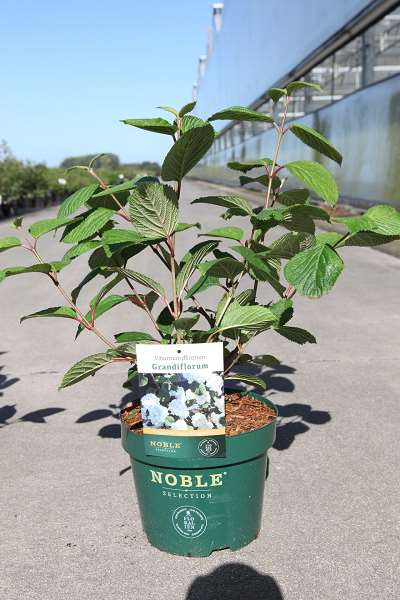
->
122;393;277;556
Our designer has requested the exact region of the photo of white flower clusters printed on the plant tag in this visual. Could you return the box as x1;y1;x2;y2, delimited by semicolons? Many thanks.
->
141;373;225;430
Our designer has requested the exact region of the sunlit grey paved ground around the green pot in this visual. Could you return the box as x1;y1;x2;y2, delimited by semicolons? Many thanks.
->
0;183;400;600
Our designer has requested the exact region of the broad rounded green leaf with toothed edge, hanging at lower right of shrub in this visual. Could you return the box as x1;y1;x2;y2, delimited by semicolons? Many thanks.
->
285;239;343;298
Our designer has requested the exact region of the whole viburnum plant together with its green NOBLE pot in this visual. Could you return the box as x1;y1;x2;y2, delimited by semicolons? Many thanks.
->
0;82;400;556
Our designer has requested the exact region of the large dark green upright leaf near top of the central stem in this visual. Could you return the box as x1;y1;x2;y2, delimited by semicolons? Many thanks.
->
161;125;215;181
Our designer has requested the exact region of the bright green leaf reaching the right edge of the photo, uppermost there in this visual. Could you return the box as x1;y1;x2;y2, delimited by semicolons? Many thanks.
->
334;204;400;236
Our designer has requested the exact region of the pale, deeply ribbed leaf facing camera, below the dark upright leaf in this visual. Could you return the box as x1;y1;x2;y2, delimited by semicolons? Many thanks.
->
129;183;178;238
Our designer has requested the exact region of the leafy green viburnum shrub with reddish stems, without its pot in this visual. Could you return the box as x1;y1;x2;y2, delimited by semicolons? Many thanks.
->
0;81;400;394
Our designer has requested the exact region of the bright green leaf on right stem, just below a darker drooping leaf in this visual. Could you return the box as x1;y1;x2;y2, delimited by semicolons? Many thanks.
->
285;160;339;204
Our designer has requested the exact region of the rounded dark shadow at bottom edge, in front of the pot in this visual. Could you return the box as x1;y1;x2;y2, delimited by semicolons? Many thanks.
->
185;563;284;600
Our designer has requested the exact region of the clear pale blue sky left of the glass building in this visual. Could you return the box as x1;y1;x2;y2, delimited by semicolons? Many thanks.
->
0;0;211;166
